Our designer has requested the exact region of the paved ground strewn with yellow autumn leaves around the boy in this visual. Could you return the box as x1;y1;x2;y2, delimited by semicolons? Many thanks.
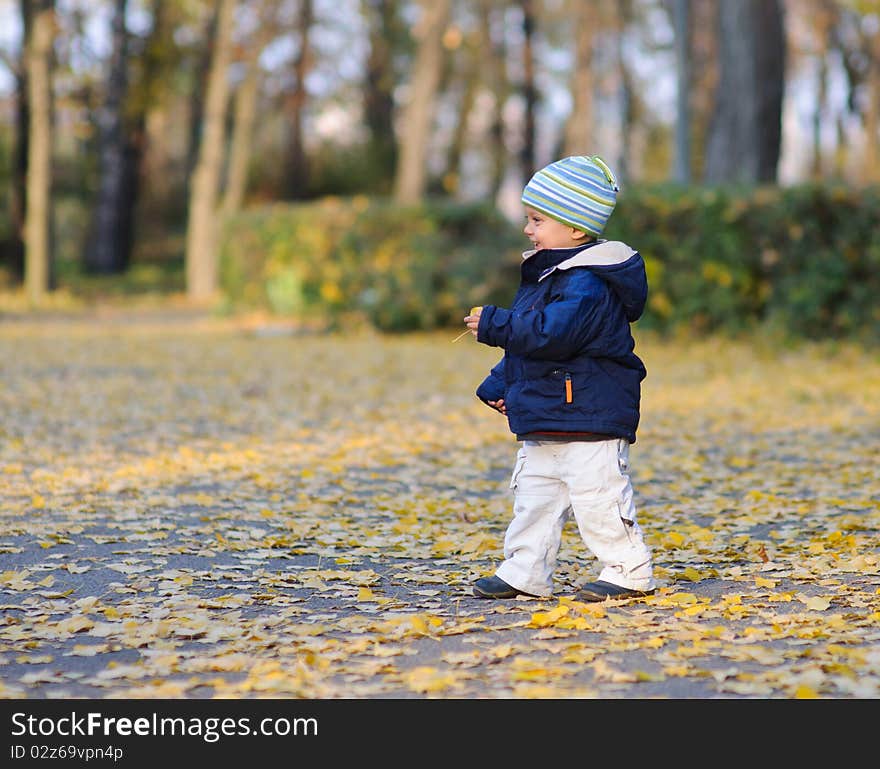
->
0;318;880;698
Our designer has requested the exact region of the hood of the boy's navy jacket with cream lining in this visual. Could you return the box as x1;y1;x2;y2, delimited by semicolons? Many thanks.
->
523;240;648;323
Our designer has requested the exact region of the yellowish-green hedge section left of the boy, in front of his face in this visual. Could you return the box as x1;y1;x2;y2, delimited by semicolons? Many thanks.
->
220;198;527;331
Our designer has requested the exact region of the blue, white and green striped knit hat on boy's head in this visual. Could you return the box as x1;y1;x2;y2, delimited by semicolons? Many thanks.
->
522;155;618;237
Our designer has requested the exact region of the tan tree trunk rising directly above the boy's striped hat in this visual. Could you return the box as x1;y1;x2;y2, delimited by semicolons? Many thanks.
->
562;0;595;156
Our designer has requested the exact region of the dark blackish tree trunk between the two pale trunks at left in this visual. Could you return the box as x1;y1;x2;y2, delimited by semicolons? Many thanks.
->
84;0;130;274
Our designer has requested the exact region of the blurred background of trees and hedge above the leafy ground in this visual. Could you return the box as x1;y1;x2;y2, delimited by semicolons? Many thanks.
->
0;0;880;341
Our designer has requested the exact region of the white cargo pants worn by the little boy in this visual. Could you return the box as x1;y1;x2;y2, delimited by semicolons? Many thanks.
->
496;440;656;596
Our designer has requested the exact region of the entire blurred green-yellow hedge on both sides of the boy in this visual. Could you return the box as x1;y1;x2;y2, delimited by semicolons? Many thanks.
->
221;185;880;340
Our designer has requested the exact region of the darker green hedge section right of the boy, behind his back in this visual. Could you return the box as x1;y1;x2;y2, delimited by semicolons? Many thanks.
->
606;185;880;339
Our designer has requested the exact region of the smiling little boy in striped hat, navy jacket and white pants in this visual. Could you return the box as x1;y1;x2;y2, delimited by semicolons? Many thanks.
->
464;155;656;601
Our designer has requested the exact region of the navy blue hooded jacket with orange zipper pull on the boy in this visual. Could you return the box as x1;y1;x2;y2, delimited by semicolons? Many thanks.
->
477;240;648;443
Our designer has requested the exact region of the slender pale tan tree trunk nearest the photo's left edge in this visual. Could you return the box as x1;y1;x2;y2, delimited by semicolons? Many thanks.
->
24;0;55;305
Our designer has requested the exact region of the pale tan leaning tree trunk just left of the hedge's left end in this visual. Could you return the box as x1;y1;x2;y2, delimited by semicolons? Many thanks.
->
186;0;235;304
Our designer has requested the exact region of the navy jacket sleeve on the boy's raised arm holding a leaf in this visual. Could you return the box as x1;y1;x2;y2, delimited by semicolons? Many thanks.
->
477;269;611;360
